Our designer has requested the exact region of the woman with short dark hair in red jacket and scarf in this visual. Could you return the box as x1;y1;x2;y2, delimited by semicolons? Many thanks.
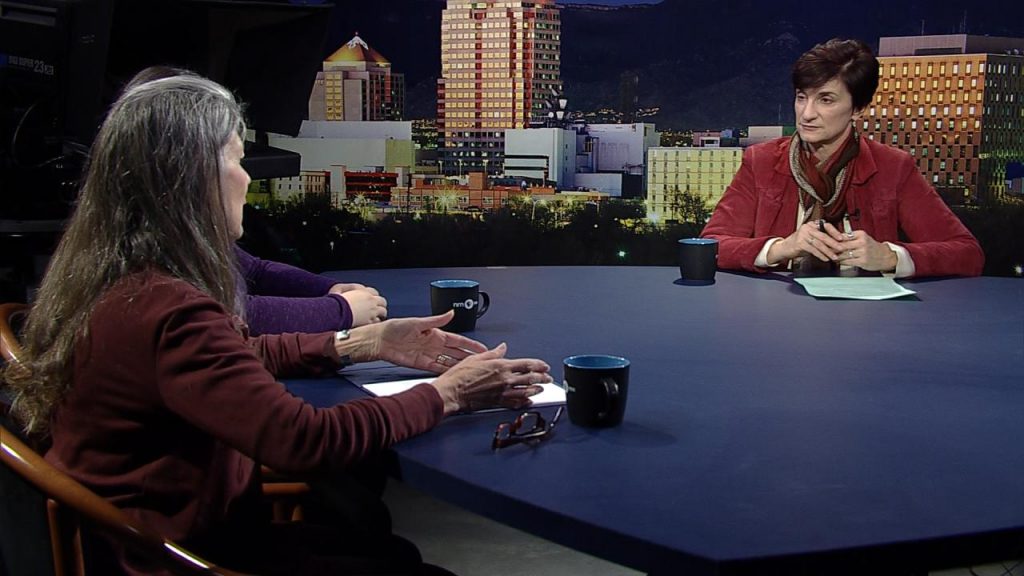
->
702;39;985;278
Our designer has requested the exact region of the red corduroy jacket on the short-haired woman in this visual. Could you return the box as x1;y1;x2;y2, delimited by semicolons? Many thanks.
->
701;137;985;277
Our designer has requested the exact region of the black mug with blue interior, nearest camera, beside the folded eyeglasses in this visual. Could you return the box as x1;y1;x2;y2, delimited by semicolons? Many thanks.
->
562;354;630;427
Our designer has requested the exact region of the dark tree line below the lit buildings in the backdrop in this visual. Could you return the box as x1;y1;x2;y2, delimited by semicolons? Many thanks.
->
241;195;1024;276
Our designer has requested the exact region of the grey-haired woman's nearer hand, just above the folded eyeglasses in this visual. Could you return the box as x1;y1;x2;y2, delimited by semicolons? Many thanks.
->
433;343;551;415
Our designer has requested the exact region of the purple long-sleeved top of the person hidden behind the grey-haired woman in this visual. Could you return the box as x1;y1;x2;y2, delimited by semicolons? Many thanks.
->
234;246;352;336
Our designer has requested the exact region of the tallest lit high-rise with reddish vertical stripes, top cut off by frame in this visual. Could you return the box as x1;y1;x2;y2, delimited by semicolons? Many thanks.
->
437;0;562;174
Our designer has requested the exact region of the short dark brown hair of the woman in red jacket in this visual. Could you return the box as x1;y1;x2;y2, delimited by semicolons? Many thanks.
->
793;38;879;110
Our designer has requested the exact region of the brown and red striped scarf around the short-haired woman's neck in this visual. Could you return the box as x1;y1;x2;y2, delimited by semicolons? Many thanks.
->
790;129;860;225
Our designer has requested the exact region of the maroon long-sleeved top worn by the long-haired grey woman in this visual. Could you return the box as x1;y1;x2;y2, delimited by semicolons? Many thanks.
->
46;273;443;547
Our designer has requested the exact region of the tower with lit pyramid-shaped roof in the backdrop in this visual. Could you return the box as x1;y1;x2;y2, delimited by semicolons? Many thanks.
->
309;33;406;122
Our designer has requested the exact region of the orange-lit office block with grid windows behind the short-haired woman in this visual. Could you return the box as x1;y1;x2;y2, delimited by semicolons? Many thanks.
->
858;34;1024;204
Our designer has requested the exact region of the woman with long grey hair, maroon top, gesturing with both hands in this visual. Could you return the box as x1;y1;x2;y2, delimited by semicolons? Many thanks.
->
3;76;551;574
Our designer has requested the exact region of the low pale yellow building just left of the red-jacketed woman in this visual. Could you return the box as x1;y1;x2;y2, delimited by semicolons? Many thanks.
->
647;148;743;223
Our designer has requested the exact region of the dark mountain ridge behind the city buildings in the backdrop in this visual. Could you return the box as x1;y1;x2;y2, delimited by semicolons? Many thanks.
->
325;0;1024;129
